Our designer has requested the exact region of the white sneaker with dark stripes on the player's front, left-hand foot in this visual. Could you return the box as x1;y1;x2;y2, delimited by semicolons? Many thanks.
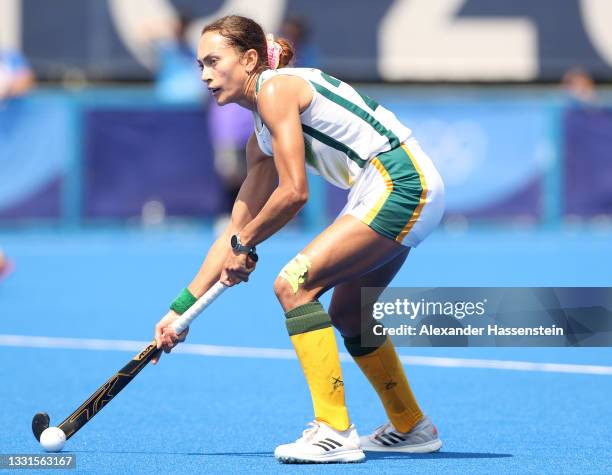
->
274;420;365;463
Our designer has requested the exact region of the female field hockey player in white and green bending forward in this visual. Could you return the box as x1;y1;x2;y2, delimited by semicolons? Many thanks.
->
155;16;444;462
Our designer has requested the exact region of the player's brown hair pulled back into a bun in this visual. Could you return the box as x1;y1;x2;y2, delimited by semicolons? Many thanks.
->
202;15;294;72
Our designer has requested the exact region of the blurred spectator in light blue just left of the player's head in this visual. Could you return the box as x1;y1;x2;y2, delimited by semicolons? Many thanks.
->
144;15;205;102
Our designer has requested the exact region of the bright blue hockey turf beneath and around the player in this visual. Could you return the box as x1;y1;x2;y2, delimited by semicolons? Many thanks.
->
0;229;612;473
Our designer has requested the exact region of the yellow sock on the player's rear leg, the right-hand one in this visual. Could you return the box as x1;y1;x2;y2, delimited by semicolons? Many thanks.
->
345;337;423;432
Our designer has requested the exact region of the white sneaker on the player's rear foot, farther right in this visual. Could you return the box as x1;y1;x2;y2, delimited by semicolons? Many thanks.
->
360;416;442;454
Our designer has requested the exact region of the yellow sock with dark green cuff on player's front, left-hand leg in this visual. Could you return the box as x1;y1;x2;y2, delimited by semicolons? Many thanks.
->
286;302;350;431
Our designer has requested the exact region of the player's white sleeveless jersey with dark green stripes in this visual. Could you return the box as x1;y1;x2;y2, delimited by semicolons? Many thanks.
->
254;68;412;189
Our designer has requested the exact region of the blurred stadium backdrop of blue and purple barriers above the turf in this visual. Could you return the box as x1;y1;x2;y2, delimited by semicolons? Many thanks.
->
0;0;612;229
